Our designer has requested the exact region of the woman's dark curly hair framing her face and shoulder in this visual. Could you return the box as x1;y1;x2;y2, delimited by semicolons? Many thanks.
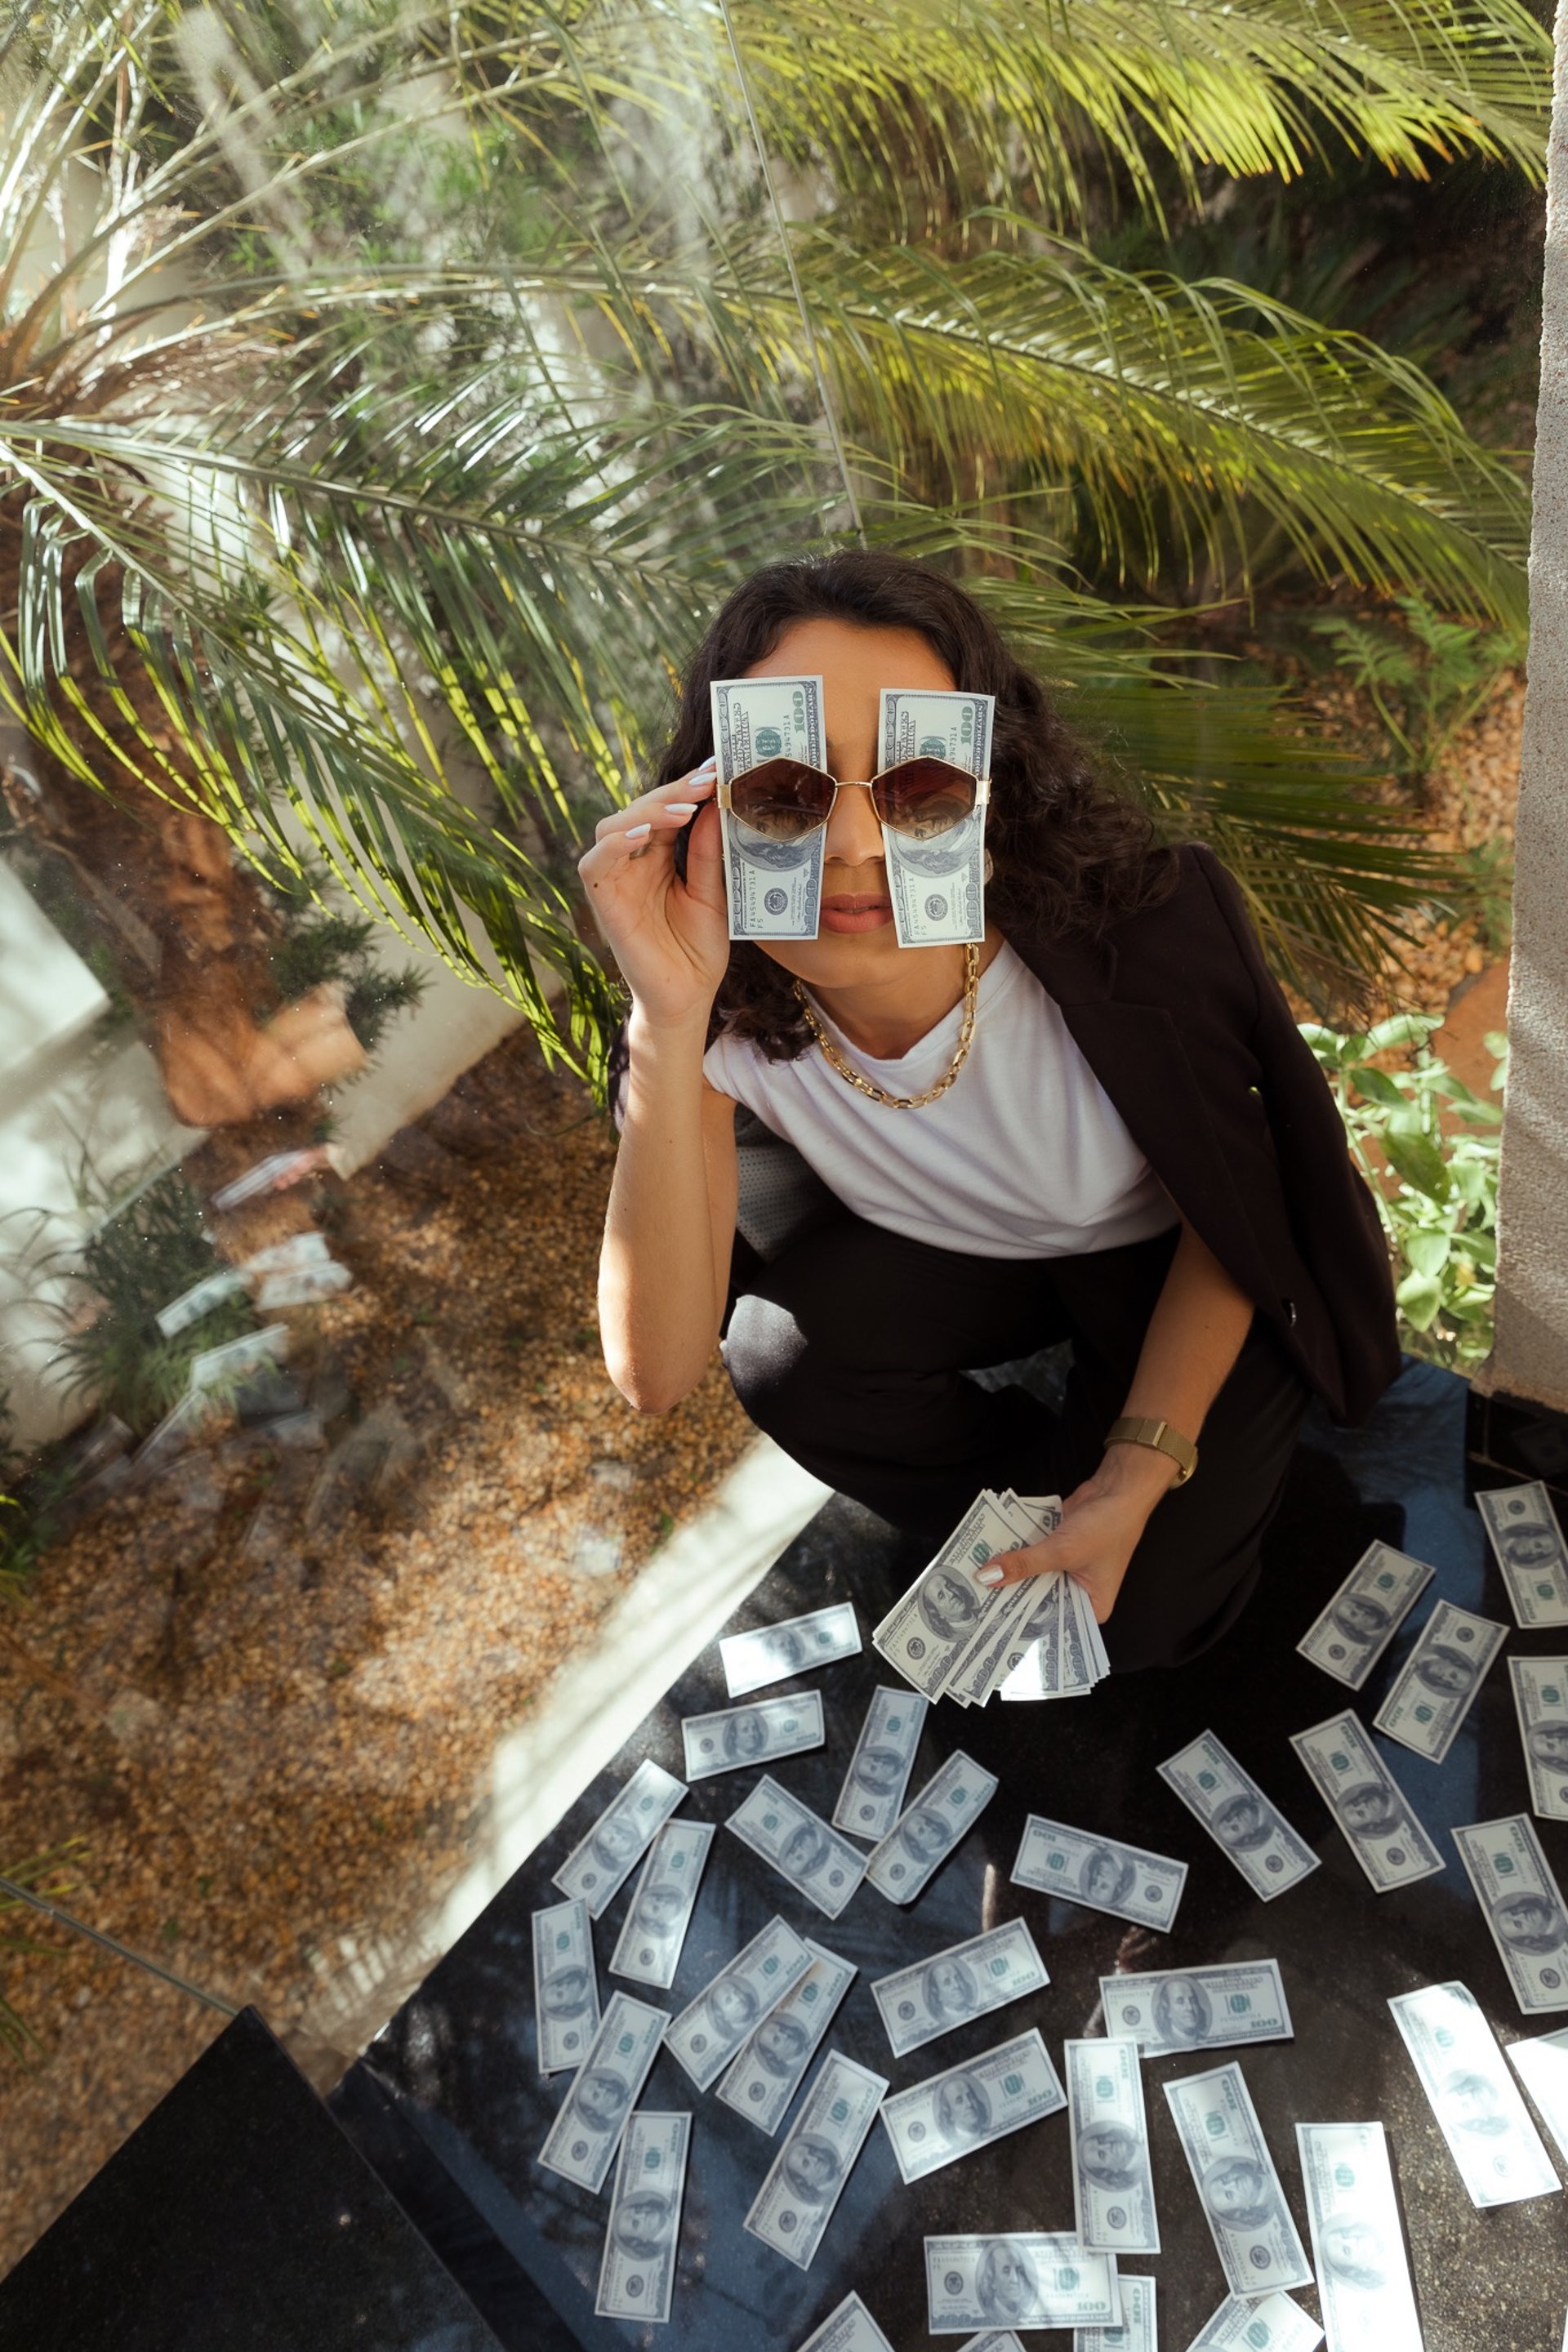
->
653;548;1175;1061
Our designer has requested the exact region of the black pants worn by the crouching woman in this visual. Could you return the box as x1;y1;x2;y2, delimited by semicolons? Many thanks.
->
724;1211;1309;1673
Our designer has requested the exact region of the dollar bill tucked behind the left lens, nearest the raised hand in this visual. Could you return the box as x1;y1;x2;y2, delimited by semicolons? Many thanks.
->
712;677;827;938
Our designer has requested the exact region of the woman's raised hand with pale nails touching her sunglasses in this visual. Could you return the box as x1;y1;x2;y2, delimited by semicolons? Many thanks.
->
578;760;728;1028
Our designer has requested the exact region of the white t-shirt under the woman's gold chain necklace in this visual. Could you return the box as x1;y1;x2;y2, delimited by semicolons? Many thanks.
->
703;946;1178;1258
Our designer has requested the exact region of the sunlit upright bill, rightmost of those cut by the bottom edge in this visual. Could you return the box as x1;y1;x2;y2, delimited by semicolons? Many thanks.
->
1295;2124;1423;2352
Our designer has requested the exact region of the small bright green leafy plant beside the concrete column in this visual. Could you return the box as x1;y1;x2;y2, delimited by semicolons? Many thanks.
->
1303;1013;1507;1371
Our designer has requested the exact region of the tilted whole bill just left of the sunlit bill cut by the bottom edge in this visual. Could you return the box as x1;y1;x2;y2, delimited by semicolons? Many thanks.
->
1166;2058;1312;2296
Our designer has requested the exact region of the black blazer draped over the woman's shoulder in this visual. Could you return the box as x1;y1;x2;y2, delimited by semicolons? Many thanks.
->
1011;844;1399;1425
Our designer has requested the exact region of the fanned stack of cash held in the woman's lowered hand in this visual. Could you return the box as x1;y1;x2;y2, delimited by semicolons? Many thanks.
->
872;1486;1110;1708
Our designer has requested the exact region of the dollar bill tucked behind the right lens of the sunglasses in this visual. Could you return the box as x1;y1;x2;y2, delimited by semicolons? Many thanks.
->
877;687;997;948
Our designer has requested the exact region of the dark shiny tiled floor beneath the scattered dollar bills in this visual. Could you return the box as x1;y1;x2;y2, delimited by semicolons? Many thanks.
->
339;1364;1568;2352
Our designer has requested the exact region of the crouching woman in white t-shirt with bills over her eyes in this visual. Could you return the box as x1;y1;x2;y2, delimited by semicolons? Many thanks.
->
581;550;1399;1670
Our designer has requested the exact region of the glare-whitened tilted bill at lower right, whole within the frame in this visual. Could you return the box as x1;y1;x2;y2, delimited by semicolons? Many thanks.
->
1389;1985;1561;2211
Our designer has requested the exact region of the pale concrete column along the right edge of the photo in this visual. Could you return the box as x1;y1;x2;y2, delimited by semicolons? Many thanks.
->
1477;0;1568;1411
